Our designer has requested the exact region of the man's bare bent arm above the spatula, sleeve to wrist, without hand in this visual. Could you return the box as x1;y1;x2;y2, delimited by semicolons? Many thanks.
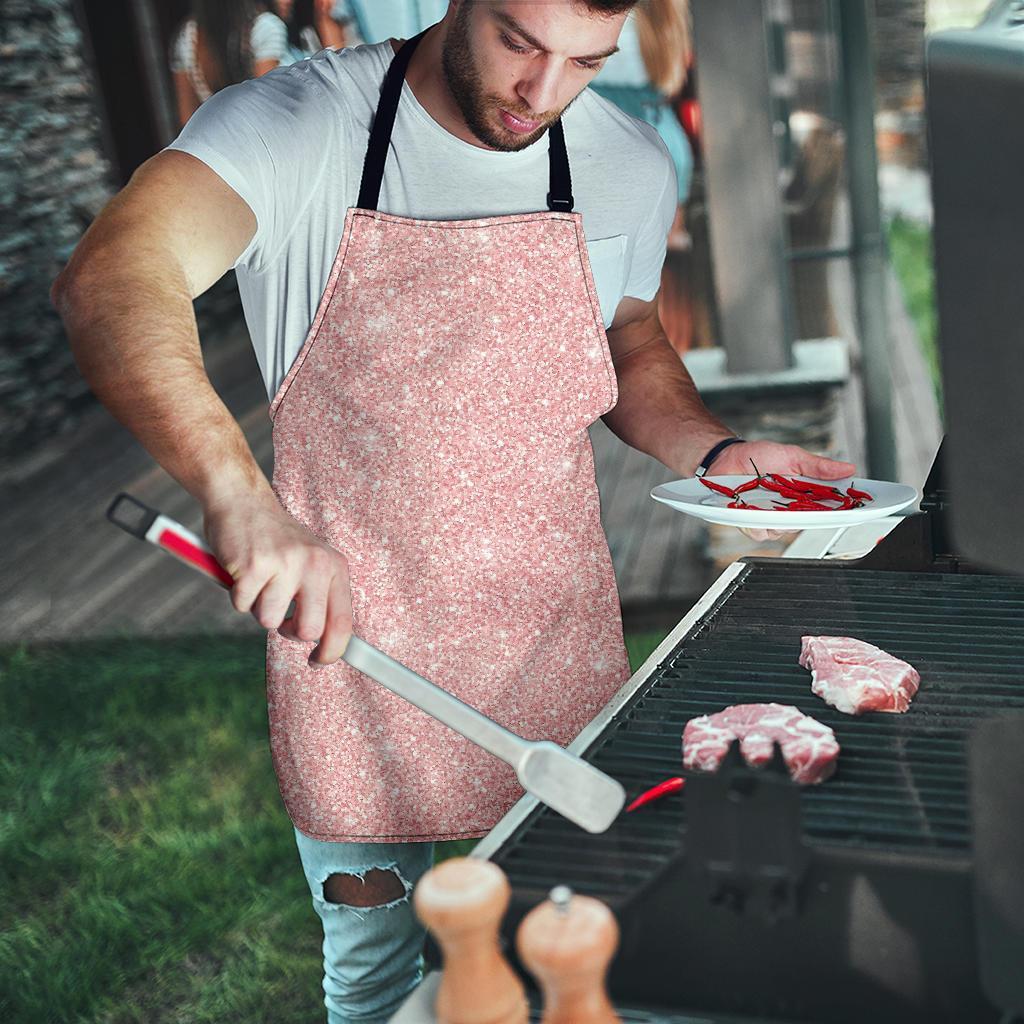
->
51;151;268;505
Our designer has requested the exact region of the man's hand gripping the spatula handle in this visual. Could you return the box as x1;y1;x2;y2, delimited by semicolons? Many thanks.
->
203;492;352;666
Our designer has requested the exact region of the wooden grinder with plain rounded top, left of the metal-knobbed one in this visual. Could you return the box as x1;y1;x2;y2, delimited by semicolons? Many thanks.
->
413;857;529;1024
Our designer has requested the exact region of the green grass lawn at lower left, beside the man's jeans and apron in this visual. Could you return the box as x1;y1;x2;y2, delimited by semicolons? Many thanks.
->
0;635;663;1024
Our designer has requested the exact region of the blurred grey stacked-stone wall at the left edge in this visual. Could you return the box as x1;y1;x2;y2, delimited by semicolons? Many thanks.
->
0;0;113;461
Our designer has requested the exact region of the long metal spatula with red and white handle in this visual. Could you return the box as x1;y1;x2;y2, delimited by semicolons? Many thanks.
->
106;494;626;833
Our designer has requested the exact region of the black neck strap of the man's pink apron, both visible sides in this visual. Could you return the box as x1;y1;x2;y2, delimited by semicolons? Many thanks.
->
356;29;573;213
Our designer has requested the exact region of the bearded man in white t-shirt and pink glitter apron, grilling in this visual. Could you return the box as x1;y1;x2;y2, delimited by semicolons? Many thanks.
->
54;0;853;1024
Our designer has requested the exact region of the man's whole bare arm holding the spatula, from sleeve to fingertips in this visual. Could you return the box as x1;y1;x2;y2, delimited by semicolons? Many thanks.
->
51;151;351;663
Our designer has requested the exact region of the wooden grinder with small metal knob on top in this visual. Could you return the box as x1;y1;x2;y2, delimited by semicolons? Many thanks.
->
516;886;620;1024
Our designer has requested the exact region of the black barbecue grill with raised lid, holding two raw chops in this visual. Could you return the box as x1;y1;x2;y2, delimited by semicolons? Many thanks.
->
399;9;1024;1024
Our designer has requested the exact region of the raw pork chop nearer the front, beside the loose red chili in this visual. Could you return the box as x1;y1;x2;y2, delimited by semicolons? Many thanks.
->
683;703;839;783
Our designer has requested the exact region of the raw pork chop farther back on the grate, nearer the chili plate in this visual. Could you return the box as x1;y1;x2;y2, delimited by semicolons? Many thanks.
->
800;637;921;715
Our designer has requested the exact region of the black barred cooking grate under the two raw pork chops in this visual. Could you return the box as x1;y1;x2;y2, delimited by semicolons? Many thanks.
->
492;561;1024;898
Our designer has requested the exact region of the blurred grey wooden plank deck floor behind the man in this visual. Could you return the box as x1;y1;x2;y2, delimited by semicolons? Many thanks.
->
0;237;940;643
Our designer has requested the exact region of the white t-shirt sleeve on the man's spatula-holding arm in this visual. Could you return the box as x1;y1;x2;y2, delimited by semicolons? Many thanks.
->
161;61;333;273
